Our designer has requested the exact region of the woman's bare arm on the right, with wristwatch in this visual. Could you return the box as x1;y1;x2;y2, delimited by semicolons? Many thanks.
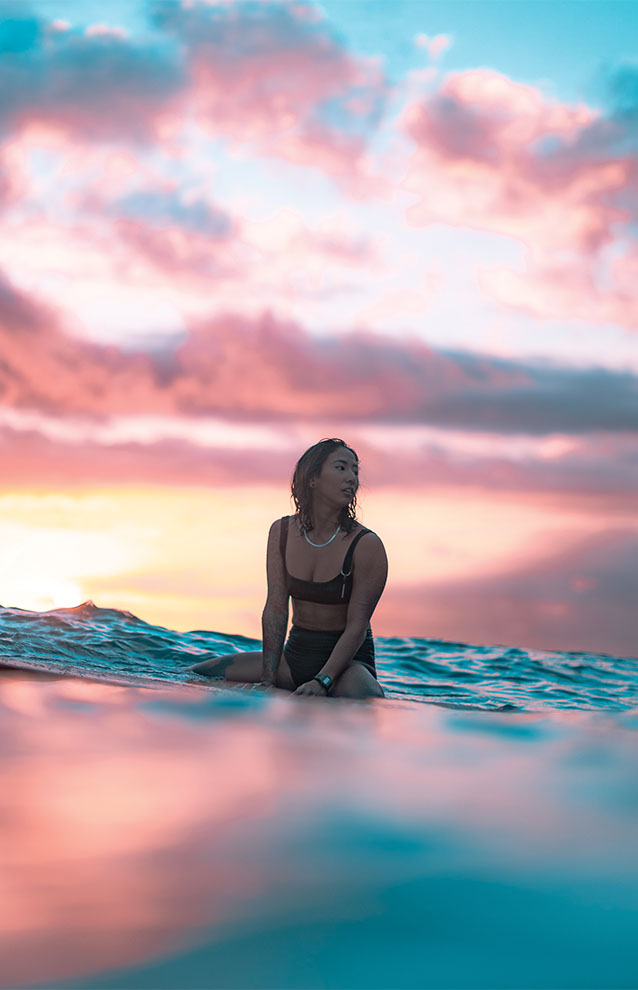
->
320;533;388;681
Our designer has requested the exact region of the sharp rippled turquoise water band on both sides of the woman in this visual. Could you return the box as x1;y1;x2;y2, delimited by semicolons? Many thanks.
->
0;602;638;711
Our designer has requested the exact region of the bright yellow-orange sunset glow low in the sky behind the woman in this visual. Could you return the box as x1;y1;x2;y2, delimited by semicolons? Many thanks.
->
0;483;623;639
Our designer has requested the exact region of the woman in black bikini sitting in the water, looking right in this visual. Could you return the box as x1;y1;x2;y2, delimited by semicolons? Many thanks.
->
191;439;388;698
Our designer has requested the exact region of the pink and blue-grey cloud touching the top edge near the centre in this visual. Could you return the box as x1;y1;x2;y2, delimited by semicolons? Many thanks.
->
150;0;388;165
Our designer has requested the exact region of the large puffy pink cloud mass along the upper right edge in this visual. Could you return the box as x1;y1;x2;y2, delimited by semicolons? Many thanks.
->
400;69;638;328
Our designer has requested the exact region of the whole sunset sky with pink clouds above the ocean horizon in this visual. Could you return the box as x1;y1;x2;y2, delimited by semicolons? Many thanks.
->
0;0;638;656
